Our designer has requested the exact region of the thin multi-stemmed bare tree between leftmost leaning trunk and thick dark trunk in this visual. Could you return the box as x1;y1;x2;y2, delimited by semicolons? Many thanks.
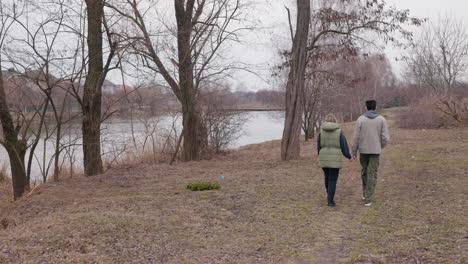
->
9;1;74;182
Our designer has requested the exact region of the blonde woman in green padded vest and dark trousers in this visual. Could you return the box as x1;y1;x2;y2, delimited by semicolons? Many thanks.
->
317;114;351;207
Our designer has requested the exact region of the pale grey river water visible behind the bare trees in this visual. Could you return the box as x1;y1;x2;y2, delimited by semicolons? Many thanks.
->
0;112;284;180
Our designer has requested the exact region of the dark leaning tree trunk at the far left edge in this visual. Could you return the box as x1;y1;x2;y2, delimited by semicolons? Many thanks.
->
0;76;29;200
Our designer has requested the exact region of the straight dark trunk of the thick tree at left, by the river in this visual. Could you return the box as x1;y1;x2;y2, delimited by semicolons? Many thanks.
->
82;0;104;176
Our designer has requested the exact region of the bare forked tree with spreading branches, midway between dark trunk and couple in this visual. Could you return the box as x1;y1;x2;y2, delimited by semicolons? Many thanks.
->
110;0;250;161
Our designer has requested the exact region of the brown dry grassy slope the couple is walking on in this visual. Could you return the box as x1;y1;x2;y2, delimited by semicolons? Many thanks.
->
0;109;468;263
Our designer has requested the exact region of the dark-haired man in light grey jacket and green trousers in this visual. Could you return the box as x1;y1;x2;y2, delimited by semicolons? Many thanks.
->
352;100;390;206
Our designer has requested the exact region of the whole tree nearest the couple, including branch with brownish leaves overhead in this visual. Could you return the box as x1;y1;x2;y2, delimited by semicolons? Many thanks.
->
281;0;421;160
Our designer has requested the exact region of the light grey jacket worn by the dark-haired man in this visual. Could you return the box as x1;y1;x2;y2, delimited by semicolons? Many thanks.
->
352;111;390;155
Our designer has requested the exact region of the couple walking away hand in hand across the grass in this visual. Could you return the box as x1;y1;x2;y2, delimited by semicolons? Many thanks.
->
317;100;390;206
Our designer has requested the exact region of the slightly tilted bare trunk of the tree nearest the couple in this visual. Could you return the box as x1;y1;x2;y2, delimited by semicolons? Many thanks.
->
281;0;310;160
